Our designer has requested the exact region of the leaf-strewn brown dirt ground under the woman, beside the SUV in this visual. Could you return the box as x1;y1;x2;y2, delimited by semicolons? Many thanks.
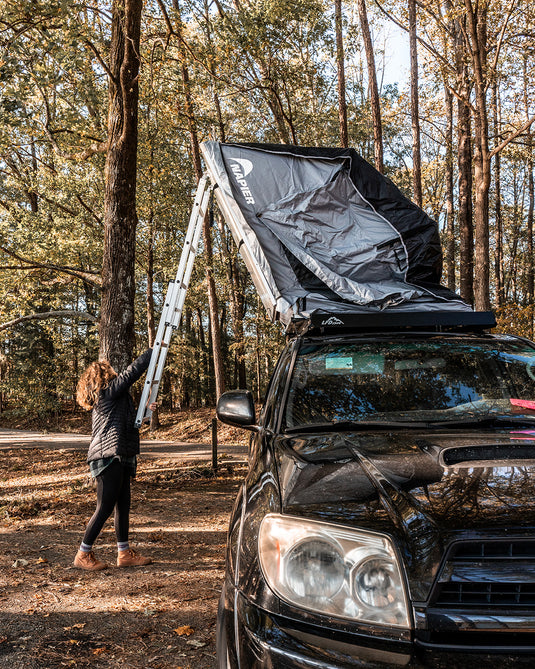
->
0;449;245;669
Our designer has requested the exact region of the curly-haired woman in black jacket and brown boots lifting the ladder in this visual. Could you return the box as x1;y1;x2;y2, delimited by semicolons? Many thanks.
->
74;349;156;571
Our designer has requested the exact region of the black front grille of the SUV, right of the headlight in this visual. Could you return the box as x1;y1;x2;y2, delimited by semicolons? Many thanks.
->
431;539;535;609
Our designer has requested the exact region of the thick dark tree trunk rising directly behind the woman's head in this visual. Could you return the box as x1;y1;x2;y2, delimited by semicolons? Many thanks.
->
100;0;142;371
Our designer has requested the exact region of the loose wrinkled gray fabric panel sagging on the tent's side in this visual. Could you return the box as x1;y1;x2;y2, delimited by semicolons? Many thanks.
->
258;171;422;305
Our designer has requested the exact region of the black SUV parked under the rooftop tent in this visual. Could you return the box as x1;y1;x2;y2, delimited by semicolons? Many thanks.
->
218;318;535;669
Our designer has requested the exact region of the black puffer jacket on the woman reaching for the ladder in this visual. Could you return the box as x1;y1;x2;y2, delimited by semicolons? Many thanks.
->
87;349;152;462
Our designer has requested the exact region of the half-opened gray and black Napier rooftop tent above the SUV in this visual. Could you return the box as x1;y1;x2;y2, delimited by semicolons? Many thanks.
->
202;142;471;325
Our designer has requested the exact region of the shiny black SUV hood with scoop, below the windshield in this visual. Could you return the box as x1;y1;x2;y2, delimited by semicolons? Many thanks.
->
275;430;535;601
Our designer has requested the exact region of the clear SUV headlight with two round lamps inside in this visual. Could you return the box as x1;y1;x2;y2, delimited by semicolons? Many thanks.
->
258;514;410;628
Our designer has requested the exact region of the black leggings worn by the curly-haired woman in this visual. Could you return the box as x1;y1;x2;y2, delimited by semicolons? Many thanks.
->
83;460;130;546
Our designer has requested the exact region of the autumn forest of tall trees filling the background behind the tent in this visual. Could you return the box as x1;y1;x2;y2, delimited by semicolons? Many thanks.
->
0;0;535;416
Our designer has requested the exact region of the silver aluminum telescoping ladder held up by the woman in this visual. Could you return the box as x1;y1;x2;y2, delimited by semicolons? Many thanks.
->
135;174;212;427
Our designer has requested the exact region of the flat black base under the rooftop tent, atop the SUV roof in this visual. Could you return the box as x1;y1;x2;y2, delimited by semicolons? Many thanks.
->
287;311;496;335
